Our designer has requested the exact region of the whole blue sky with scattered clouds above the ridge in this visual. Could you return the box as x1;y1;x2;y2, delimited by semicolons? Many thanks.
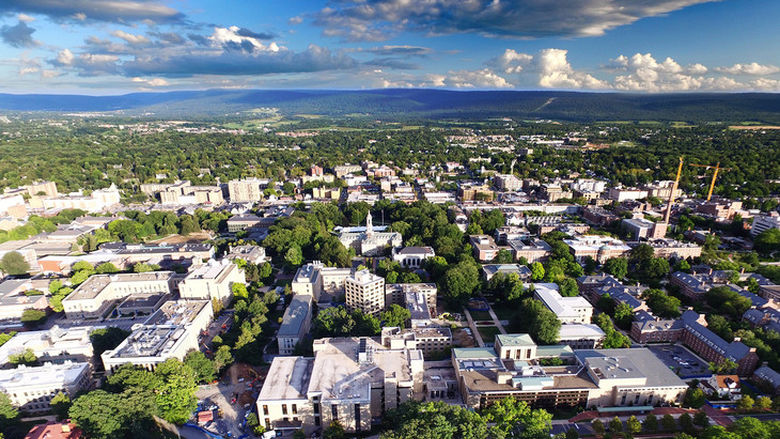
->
0;0;780;95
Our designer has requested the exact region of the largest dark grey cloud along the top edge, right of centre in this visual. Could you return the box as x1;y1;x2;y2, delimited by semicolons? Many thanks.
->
314;0;715;41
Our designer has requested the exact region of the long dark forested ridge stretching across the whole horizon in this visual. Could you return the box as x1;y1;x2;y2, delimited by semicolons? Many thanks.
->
0;89;780;123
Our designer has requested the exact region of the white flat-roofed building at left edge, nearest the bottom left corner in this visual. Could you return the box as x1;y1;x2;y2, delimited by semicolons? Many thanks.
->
0;361;92;415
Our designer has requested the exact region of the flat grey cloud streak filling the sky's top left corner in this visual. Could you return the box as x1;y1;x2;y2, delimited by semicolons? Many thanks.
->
0;0;184;23
